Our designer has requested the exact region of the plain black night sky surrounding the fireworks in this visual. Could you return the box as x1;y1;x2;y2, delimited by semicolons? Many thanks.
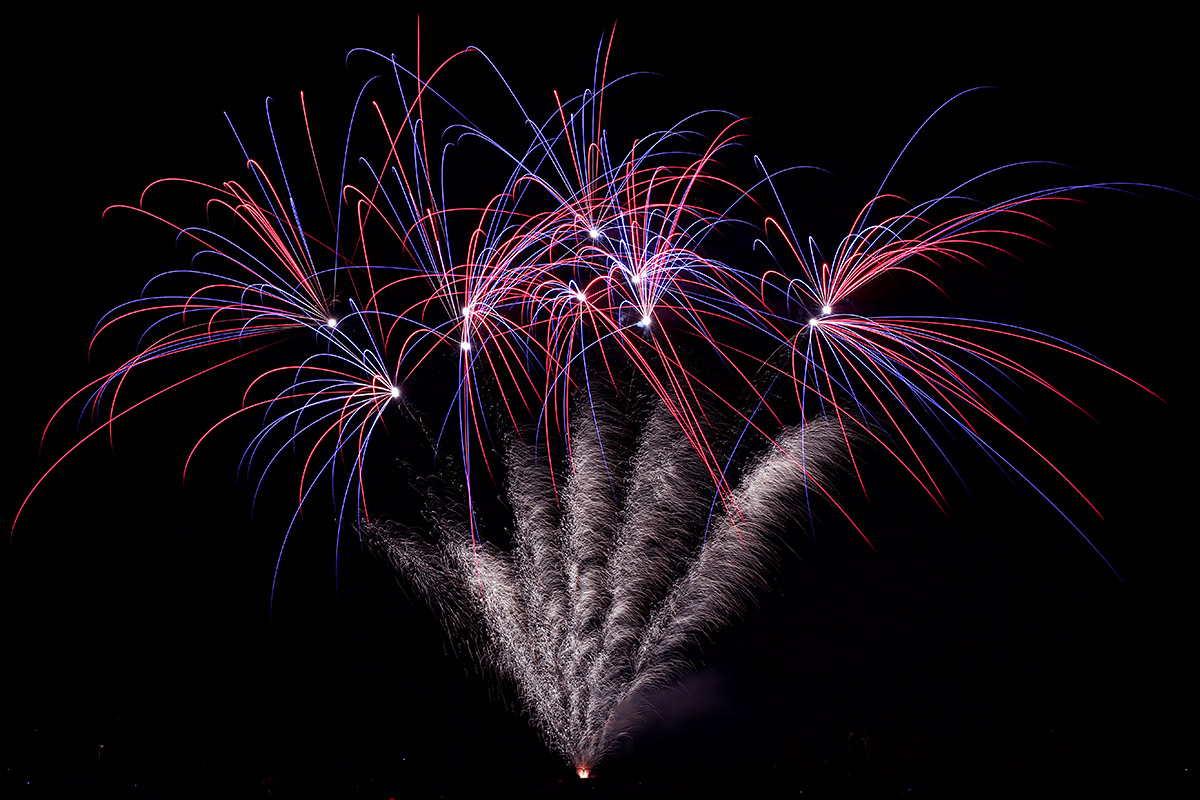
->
7;8;1200;798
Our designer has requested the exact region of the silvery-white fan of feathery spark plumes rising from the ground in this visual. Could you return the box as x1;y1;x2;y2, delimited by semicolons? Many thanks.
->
362;403;844;776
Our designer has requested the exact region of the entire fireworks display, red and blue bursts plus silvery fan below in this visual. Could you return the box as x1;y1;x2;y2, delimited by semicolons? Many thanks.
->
13;29;1161;774
